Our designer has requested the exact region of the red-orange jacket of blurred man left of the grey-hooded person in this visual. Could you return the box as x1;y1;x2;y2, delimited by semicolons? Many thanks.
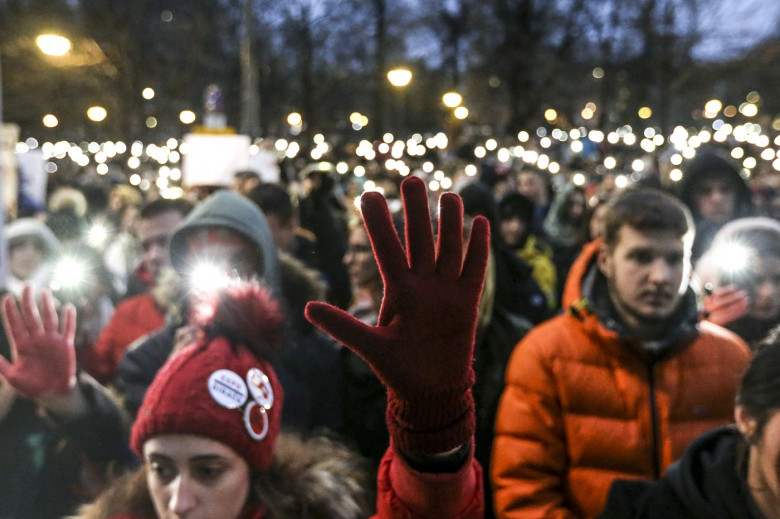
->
79;292;165;384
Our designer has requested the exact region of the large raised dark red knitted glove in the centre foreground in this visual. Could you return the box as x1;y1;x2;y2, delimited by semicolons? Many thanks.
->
306;177;489;454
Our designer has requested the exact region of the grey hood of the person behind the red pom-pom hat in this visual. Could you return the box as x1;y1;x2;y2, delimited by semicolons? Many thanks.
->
169;189;281;294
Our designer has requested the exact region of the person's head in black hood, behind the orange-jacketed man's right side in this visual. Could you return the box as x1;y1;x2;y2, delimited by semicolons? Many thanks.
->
678;151;753;265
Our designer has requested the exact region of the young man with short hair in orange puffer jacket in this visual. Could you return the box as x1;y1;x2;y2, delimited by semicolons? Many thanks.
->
491;189;749;519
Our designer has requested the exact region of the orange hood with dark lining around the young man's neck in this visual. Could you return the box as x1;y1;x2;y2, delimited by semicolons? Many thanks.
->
563;238;700;360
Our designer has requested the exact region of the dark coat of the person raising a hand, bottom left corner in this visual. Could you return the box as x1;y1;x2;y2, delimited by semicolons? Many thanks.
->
0;378;135;519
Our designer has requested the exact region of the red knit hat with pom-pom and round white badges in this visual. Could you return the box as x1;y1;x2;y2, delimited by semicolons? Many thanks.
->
130;283;284;472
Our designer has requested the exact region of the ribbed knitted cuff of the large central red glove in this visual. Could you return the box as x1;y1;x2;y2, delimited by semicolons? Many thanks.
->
387;387;476;455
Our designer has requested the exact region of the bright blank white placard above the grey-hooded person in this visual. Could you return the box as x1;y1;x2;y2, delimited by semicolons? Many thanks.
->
182;133;251;187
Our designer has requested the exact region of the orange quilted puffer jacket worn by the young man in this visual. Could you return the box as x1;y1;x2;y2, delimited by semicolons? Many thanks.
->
491;242;749;519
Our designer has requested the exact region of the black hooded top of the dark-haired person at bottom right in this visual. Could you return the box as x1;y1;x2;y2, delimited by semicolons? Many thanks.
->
599;426;764;519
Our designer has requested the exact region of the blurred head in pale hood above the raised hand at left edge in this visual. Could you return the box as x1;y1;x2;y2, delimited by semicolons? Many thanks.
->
5;218;62;296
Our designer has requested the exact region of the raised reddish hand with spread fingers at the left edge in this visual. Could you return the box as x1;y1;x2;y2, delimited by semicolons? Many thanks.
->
0;286;76;398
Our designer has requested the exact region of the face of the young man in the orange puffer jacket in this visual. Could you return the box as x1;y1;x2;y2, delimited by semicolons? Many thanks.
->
598;225;690;330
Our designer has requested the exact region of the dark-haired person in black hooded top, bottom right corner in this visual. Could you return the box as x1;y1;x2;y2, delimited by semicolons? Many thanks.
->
599;328;780;519
